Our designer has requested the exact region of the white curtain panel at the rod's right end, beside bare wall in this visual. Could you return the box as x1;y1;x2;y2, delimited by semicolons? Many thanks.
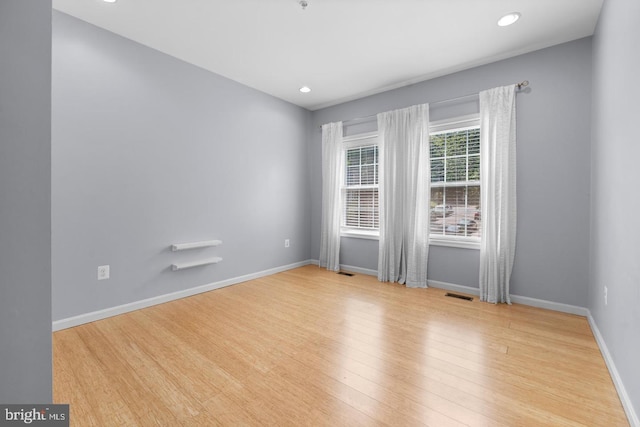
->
480;85;516;304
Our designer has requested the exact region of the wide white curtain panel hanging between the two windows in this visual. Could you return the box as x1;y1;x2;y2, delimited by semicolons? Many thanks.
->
378;104;431;288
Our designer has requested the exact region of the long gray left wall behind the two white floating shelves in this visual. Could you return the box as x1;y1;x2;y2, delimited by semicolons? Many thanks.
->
52;12;310;320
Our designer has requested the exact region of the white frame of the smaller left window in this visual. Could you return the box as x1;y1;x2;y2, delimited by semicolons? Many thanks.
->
340;131;380;240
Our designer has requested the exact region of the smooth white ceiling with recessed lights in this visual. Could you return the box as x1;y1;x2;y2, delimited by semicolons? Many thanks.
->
53;0;603;110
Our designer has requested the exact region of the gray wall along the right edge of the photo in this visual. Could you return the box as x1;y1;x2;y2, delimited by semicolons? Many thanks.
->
589;0;640;415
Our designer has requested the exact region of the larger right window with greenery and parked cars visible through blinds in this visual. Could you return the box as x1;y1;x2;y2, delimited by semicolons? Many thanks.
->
430;115;482;246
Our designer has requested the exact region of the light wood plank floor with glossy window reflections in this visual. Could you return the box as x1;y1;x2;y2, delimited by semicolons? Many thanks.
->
53;266;629;427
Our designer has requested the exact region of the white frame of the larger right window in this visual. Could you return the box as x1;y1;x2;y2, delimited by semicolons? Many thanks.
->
429;113;482;249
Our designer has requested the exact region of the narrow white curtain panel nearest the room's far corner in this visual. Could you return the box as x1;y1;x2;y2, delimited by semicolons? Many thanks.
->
320;122;344;271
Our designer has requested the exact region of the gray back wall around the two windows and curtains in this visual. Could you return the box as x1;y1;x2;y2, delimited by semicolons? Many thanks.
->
309;38;591;307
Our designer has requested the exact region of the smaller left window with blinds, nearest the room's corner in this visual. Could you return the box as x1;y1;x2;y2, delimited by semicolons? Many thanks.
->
342;134;380;238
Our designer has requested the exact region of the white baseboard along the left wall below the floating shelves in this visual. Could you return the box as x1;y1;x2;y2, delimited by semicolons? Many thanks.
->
51;260;313;332
